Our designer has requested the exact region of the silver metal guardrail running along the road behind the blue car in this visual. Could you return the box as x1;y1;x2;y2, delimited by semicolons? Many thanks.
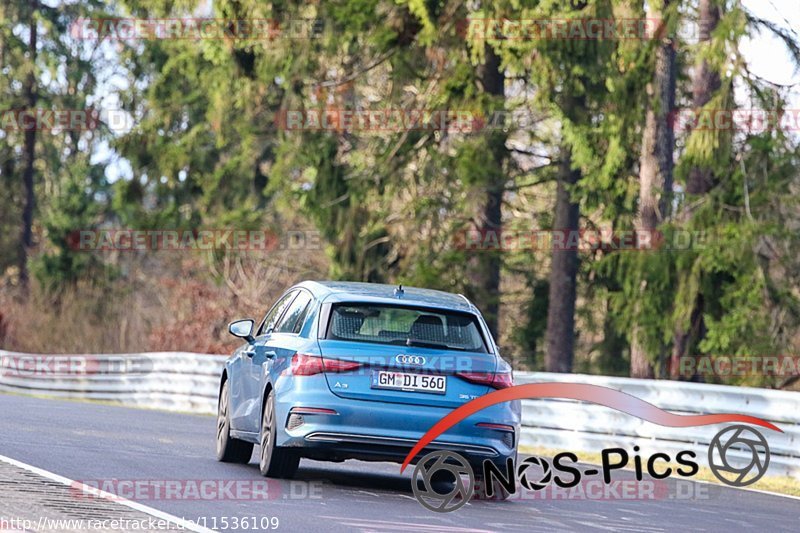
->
0;350;800;478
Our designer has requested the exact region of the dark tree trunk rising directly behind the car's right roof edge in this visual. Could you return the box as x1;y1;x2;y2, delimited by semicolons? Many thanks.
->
470;45;508;338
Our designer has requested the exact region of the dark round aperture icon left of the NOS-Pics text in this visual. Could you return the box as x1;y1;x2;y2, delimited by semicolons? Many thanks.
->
411;451;475;513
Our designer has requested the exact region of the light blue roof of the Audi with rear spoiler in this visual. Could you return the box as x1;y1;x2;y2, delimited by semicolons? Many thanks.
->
296;281;477;313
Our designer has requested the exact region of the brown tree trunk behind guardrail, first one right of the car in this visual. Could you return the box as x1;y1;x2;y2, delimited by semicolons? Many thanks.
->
545;146;581;373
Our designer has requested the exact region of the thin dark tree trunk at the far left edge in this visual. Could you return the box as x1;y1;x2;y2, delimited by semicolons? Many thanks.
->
19;9;38;292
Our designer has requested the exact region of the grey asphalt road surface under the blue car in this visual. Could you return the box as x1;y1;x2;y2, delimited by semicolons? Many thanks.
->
0;394;800;532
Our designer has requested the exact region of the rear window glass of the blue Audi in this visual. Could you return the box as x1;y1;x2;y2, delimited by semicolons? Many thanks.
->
327;304;487;353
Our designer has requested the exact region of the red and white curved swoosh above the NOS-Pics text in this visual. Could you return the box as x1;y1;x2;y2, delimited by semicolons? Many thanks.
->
400;383;783;473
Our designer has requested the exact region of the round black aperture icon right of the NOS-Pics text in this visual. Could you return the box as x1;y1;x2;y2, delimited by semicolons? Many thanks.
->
708;425;769;487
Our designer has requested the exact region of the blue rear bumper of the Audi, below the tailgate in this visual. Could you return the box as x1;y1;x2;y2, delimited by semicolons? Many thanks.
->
276;376;520;463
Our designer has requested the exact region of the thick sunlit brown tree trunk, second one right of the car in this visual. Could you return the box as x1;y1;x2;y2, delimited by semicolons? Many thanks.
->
630;0;676;378
